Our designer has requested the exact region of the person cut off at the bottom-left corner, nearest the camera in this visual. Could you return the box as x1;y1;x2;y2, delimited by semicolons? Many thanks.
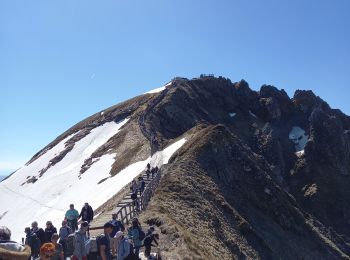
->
0;226;31;260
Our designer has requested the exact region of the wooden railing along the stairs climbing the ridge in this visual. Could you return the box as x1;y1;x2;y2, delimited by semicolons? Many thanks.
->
90;169;161;230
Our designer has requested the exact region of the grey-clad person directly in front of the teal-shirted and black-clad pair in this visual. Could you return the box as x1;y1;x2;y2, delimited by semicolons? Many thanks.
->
71;221;89;260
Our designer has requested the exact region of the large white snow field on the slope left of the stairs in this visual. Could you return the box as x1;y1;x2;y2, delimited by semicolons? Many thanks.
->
0;116;186;241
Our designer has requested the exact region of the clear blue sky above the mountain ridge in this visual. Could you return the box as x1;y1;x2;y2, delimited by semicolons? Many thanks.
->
0;0;350;175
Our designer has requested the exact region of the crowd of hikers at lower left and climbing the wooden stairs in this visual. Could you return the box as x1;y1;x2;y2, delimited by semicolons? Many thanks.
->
0;164;159;260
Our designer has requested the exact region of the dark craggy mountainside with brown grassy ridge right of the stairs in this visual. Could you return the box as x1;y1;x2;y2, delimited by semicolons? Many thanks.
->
133;77;350;259
